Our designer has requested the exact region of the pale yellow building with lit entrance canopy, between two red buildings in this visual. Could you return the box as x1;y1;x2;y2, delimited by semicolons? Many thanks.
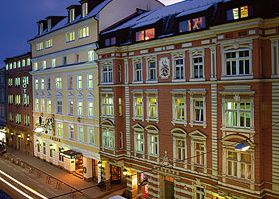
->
29;0;164;181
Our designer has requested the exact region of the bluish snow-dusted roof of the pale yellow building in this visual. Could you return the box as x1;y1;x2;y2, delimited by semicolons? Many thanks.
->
30;0;113;41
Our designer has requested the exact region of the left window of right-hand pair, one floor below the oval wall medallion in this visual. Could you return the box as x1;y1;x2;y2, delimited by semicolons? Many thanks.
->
172;94;186;124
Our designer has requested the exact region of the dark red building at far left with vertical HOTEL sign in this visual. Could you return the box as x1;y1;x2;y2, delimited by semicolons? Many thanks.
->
4;52;33;155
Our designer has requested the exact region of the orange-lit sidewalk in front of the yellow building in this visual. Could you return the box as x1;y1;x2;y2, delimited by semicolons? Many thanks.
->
7;147;125;199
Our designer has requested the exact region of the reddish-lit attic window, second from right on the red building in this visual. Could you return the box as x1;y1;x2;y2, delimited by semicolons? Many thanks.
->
179;17;206;33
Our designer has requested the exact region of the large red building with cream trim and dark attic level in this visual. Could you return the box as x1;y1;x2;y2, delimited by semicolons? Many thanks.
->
96;0;279;199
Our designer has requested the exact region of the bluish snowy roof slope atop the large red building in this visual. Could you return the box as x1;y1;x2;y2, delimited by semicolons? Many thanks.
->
102;0;231;34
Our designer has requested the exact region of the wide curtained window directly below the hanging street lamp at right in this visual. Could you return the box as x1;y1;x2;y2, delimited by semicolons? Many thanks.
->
227;151;252;179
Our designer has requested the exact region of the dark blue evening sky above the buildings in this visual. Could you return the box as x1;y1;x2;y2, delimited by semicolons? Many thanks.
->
0;0;181;68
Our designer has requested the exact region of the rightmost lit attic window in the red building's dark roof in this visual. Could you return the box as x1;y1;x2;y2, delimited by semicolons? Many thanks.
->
227;5;252;21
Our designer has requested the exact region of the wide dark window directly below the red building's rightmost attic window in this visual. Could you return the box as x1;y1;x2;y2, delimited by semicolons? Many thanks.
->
225;50;250;76
